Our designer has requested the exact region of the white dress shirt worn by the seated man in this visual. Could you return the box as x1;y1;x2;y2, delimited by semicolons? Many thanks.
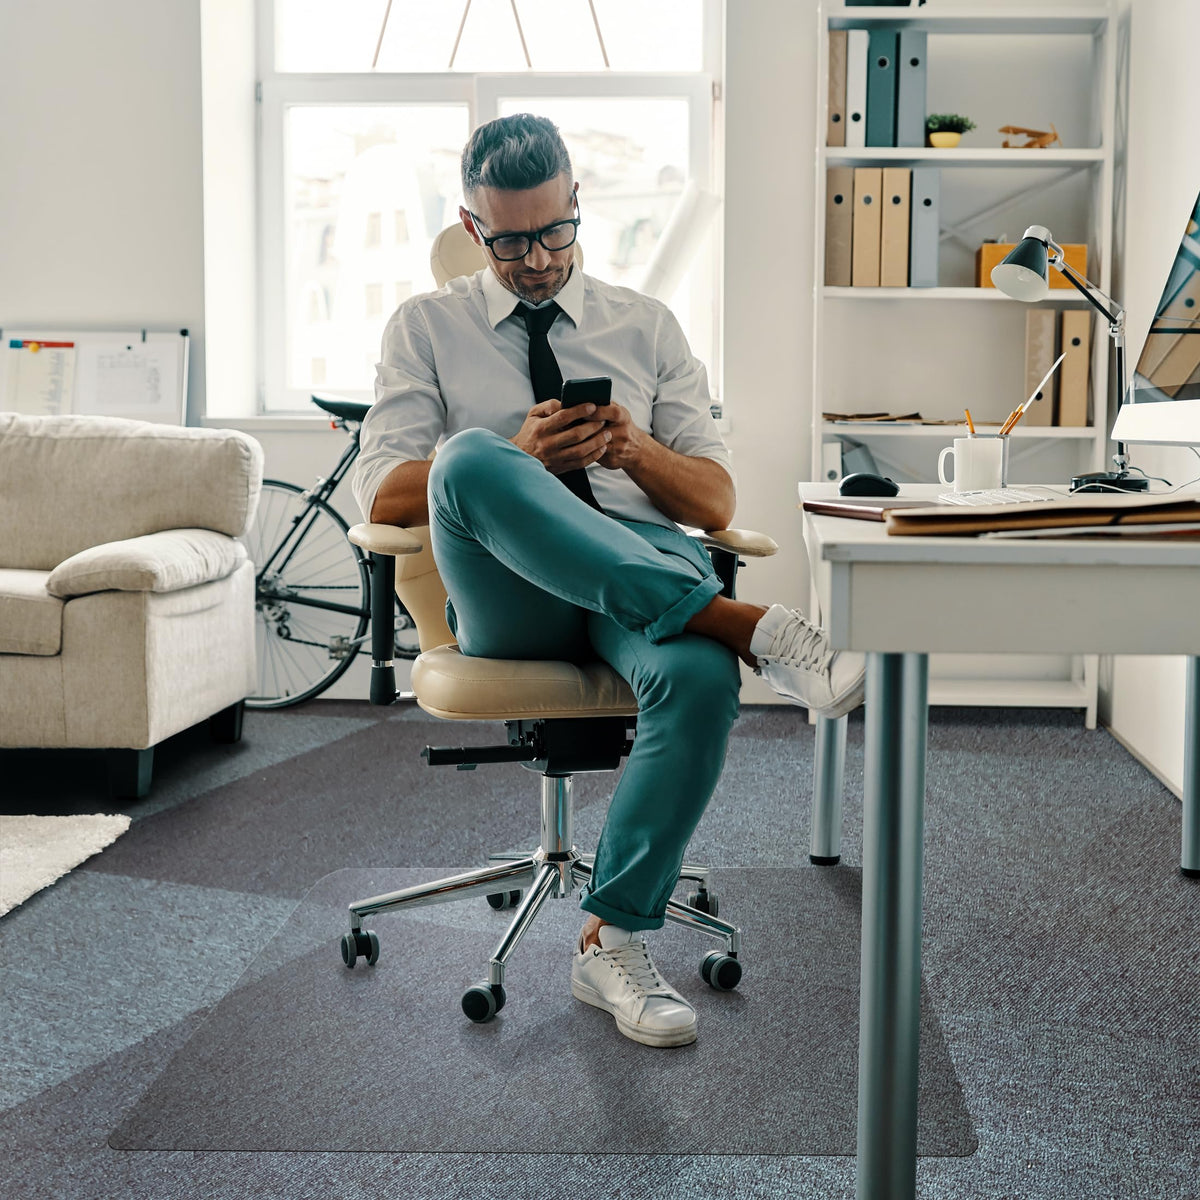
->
352;266;733;526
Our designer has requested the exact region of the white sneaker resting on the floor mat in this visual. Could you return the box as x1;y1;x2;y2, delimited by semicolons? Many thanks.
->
571;925;696;1046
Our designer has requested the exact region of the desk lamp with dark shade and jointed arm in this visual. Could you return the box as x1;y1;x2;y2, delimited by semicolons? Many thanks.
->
991;226;1150;492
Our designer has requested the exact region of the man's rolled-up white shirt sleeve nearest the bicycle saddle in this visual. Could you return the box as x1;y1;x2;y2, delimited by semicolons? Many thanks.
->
350;298;446;521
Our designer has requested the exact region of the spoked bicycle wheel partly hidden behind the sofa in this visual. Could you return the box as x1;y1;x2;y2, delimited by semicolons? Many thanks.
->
245;479;371;708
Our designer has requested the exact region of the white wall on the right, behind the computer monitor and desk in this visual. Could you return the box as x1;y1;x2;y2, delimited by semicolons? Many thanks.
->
1100;0;1200;793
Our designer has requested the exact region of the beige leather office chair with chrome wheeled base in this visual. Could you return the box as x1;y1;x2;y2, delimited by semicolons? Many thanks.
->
342;226;778;1022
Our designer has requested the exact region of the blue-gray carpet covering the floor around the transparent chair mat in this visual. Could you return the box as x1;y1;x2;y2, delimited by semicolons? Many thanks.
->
0;701;1200;1200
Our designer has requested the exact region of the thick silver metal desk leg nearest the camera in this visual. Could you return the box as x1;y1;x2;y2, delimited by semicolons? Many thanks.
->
858;653;929;1200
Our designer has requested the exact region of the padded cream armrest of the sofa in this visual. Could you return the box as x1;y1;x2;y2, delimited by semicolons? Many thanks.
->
46;529;247;599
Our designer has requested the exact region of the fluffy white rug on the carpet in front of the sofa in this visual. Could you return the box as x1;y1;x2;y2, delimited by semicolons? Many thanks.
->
0;812;130;917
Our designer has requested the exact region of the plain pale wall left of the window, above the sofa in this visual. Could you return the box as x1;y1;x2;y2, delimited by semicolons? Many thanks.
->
0;0;204;416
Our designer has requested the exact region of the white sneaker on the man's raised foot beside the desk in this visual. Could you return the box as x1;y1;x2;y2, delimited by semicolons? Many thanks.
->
750;604;866;716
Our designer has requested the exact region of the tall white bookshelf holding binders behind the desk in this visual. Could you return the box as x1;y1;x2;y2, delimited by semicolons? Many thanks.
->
811;0;1117;727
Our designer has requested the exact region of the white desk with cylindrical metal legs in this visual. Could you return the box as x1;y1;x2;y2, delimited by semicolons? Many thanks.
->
800;484;1200;1200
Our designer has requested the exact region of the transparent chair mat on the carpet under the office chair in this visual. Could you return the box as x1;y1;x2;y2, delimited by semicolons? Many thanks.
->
109;868;976;1156
